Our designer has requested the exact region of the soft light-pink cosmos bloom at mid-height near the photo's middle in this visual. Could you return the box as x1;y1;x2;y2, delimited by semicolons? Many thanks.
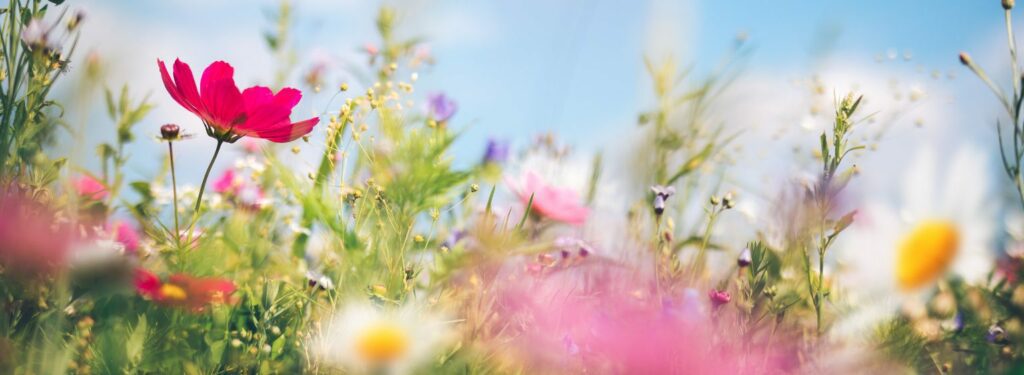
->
516;172;590;225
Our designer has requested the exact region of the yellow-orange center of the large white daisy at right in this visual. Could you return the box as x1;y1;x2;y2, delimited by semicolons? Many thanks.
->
896;220;959;290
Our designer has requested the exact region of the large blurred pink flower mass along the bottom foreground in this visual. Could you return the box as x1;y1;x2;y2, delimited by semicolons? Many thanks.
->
495;260;793;374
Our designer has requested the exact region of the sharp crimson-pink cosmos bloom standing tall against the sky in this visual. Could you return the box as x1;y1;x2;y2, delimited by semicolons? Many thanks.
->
157;59;319;142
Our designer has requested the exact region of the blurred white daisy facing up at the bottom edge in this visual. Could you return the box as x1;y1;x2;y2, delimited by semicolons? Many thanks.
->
312;303;450;374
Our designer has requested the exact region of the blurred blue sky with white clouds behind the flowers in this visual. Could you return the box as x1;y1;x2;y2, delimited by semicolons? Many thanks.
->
59;0;1009;219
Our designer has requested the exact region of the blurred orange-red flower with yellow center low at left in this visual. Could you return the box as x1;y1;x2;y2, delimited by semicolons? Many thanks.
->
135;268;236;313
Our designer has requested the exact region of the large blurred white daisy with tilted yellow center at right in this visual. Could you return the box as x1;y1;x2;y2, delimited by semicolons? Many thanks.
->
837;145;995;334
